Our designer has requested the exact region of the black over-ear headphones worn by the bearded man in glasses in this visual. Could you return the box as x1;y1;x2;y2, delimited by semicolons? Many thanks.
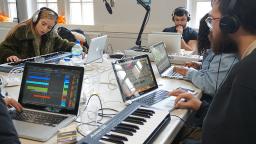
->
220;0;240;34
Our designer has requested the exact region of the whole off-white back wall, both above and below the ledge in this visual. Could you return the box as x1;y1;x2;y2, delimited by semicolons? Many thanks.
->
0;0;187;51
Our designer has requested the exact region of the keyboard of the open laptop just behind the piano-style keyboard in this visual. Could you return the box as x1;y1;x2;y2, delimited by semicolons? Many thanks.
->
136;90;169;106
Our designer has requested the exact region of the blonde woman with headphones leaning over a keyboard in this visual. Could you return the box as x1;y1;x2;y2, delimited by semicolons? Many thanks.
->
0;7;86;63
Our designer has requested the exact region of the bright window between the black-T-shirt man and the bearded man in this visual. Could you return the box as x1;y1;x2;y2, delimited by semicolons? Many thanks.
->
188;0;212;28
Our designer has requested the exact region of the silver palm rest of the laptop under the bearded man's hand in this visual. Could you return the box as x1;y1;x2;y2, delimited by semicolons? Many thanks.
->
152;96;176;111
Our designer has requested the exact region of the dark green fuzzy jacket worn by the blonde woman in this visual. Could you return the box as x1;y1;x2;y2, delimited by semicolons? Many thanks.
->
0;22;74;63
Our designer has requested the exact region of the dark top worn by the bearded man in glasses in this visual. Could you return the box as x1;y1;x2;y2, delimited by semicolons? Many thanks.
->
198;50;256;144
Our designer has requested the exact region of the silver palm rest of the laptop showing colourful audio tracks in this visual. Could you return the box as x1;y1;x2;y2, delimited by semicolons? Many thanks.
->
13;120;57;141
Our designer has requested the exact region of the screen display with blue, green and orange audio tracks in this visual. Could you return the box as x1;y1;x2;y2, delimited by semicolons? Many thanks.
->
23;68;79;109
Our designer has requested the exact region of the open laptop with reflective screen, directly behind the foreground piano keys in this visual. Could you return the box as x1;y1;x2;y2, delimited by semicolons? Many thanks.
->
112;55;175;111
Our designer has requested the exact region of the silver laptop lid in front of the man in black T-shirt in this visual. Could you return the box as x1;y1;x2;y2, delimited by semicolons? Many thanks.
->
148;32;181;54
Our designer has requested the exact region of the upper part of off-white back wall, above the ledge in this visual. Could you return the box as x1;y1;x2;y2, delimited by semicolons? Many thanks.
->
95;0;186;32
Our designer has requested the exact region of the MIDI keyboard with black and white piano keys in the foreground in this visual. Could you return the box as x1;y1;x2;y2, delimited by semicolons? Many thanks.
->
78;103;171;144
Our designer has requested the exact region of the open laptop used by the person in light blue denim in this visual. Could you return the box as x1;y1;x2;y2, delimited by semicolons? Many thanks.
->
150;42;184;79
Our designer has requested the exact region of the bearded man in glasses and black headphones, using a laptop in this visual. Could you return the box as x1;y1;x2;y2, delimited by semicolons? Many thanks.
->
170;0;256;144
